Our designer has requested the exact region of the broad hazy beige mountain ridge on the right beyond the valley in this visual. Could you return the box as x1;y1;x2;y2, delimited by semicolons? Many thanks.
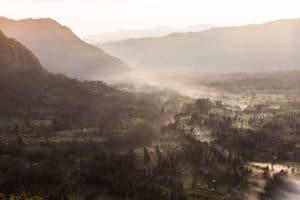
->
99;19;300;72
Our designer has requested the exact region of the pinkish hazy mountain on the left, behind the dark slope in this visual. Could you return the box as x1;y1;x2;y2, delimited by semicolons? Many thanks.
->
0;18;128;79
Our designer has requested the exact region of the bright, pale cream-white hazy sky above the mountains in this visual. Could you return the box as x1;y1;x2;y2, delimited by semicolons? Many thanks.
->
0;0;300;36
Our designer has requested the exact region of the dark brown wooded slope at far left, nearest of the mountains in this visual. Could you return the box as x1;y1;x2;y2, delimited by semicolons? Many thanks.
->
0;29;129;120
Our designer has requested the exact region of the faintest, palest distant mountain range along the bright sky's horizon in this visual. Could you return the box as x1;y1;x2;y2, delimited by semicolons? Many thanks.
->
85;24;213;44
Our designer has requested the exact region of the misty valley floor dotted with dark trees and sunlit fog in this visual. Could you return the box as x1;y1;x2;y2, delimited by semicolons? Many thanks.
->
0;72;300;200
